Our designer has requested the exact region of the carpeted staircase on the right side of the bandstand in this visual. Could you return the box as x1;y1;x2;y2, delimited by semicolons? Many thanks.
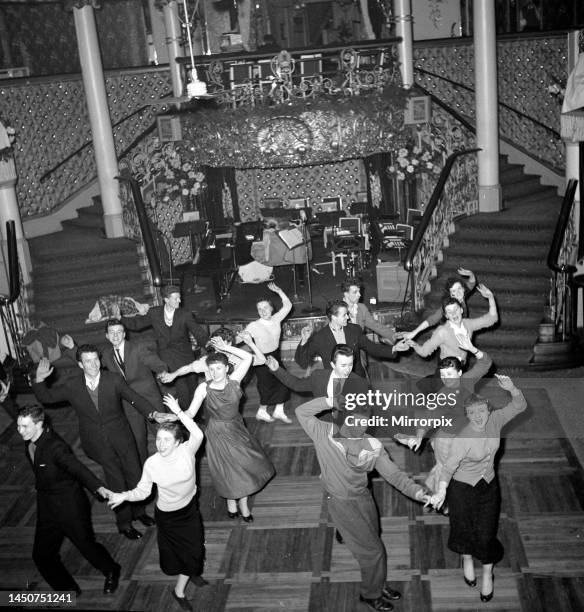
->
424;158;561;368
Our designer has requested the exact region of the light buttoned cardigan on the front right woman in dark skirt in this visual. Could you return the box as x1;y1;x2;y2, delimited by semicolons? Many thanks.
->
440;389;527;487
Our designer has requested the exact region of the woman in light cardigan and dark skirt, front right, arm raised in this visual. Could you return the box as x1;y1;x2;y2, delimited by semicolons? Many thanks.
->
431;375;527;602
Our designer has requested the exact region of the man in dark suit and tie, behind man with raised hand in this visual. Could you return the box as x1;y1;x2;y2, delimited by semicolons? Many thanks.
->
101;319;167;464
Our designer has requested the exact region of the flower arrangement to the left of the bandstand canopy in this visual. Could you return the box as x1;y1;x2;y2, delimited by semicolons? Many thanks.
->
142;143;207;202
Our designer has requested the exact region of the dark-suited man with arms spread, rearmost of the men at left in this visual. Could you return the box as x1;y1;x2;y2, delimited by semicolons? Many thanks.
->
122;285;209;410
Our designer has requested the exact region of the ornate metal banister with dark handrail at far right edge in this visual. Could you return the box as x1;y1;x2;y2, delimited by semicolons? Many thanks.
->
547;179;578;341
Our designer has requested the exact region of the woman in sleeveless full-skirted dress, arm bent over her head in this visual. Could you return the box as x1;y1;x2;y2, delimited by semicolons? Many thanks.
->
186;338;275;523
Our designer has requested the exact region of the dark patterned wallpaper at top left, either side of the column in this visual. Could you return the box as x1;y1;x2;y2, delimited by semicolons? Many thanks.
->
0;0;148;76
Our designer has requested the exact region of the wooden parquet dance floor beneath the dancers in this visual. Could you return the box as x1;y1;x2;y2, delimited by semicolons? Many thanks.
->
0;366;584;612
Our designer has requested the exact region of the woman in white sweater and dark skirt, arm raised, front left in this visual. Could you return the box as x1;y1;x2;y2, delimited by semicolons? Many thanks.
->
108;395;207;610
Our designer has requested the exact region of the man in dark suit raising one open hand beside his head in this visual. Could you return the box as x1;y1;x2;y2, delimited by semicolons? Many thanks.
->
32;344;172;540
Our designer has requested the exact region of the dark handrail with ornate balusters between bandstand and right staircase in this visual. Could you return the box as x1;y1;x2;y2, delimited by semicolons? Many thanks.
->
404;148;481;311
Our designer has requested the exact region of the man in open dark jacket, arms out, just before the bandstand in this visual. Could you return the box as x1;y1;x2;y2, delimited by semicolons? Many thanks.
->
294;300;408;376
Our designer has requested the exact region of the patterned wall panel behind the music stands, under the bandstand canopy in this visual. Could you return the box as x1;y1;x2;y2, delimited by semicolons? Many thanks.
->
235;160;367;221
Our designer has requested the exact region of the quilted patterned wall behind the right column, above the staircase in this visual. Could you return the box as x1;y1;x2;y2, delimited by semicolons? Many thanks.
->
414;34;567;170
